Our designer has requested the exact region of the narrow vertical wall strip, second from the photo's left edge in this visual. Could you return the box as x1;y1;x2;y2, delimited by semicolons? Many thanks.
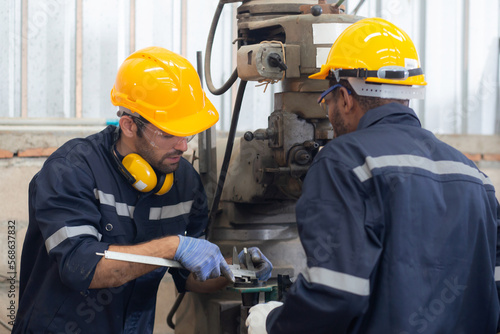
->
75;0;83;118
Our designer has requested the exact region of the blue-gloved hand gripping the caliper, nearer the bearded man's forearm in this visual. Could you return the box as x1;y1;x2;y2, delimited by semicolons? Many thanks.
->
174;235;234;282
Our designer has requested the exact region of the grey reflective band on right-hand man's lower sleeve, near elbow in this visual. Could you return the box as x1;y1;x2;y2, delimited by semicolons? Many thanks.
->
304;267;370;296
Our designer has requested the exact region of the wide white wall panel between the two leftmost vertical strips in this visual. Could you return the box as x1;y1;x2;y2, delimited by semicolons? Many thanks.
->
26;0;75;117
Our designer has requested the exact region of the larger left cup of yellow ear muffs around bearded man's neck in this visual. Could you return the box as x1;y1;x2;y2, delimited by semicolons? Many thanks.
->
122;153;157;192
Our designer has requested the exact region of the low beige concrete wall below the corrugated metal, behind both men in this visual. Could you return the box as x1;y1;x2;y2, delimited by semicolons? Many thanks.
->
0;126;500;334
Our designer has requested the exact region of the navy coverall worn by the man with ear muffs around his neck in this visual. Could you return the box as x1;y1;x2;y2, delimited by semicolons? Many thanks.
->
13;126;208;334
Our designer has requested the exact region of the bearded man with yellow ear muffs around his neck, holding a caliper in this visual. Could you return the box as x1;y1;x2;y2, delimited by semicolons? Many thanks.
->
13;47;272;334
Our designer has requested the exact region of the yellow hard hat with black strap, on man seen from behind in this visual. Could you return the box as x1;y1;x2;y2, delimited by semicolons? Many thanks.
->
309;18;427;86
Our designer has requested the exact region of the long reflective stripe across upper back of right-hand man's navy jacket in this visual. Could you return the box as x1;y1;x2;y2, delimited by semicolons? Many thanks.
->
353;154;493;185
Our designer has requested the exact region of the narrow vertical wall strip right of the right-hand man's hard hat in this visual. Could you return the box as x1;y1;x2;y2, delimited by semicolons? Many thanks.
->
461;0;470;134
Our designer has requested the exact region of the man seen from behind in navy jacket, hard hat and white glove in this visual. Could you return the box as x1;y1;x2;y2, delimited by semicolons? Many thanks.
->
247;18;500;334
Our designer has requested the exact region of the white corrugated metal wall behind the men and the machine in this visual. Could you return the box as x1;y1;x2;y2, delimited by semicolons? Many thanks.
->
0;0;500;134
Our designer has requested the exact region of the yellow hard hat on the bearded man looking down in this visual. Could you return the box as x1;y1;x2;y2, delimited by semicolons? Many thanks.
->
111;47;219;137
